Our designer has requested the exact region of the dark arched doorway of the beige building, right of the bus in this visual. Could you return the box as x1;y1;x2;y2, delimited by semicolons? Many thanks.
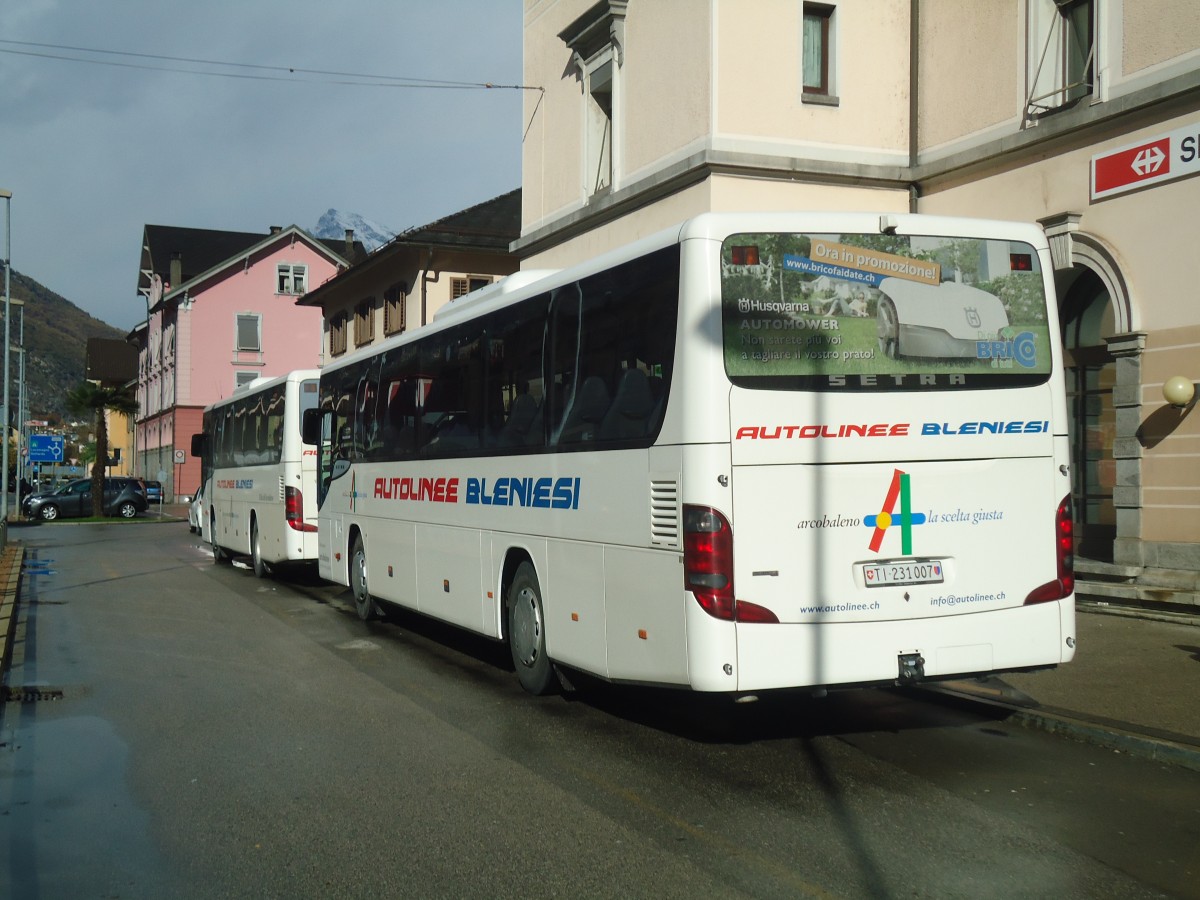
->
1061;266;1117;562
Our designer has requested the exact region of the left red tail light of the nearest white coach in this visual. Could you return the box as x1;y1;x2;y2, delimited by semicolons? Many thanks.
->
683;506;779;623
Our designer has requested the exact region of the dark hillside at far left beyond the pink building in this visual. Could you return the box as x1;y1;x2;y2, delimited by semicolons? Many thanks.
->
0;269;125;419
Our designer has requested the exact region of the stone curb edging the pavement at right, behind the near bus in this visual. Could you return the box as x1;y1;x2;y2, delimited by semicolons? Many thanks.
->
919;682;1200;772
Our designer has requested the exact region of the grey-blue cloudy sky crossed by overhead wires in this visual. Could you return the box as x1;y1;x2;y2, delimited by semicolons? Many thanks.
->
0;0;522;329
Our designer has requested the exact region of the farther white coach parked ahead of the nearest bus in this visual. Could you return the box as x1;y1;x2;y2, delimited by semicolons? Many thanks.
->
192;370;319;577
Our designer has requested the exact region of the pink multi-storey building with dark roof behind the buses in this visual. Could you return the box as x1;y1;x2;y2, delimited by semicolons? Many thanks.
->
130;224;366;500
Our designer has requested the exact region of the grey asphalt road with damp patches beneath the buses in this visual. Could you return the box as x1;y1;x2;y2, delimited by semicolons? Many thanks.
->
0;523;1200;899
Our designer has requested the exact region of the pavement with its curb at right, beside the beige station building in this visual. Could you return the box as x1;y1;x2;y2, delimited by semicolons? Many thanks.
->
926;601;1200;770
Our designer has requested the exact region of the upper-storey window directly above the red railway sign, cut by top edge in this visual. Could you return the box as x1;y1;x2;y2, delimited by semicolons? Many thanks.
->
1025;0;1096;122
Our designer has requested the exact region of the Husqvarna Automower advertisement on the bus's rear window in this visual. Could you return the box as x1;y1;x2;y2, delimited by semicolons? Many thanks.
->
721;233;1050;390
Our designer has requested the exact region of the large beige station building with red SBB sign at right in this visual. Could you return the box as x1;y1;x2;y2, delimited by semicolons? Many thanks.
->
512;0;1200;605
